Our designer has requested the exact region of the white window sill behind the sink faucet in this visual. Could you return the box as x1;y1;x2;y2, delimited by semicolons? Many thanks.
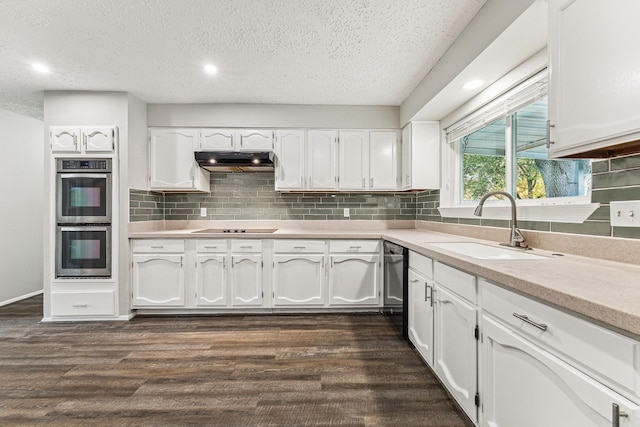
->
438;203;600;224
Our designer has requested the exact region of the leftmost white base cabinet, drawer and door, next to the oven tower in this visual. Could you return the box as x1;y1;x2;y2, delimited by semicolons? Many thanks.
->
131;240;186;308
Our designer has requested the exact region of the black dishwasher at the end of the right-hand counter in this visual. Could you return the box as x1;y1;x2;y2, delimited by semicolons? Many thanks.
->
382;240;409;339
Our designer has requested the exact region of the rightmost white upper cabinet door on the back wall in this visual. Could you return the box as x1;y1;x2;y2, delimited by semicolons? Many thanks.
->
369;131;400;190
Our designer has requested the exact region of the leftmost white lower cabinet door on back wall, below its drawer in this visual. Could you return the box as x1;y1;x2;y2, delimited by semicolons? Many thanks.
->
132;254;185;307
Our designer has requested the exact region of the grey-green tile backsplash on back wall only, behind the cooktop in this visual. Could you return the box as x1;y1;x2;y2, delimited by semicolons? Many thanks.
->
129;172;417;222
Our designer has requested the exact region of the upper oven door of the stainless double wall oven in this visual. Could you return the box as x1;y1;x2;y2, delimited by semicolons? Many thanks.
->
56;173;111;224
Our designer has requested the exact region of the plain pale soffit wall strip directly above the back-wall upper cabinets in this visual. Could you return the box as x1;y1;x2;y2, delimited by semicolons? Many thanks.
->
147;104;400;129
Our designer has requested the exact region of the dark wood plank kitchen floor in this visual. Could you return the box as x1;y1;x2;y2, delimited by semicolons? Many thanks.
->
0;297;472;426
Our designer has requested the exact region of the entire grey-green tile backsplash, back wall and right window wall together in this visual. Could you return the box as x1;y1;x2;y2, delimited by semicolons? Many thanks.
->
129;155;640;239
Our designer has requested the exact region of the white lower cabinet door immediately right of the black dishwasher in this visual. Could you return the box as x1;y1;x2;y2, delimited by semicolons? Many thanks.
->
408;270;433;367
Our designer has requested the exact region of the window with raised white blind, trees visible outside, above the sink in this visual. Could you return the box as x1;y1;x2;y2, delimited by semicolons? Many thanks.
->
447;73;591;204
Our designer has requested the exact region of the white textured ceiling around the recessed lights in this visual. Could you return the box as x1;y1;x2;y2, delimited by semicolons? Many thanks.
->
0;0;486;118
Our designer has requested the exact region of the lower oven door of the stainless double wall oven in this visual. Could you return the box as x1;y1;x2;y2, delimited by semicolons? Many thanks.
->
56;225;111;278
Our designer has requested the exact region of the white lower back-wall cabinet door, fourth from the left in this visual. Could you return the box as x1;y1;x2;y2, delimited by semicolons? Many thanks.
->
273;254;325;306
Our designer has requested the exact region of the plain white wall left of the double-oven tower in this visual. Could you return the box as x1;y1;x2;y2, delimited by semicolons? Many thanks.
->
0;110;45;305
